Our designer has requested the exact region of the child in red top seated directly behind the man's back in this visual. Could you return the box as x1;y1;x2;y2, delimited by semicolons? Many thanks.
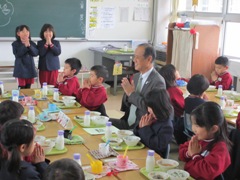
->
159;64;187;144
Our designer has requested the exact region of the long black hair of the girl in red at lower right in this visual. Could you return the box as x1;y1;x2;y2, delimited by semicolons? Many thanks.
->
190;101;232;151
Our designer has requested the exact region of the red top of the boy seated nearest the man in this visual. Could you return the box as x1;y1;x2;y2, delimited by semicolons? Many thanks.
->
80;86;107;110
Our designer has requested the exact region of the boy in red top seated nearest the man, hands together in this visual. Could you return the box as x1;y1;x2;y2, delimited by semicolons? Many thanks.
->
77;65;108;110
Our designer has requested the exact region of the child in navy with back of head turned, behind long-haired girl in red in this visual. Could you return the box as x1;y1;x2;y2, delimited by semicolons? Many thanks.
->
184;74;209;114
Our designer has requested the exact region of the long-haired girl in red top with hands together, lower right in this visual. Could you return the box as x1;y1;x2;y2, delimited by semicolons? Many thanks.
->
179;102;231;180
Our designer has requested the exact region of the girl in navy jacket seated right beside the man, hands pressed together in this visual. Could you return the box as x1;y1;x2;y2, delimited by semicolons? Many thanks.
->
134;89;174;158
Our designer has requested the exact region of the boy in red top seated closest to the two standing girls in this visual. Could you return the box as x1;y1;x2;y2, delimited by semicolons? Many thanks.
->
56;58;82;96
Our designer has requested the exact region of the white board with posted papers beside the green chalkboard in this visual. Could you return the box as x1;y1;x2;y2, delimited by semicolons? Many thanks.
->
86;0;153;40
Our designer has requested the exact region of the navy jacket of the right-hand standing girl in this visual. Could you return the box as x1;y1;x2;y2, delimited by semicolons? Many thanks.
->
37;40;61;71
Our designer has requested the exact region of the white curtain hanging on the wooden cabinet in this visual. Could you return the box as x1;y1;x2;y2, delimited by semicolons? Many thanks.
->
172;30;193;78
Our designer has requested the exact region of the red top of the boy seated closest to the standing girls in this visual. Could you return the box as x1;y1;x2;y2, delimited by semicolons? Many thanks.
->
58;77;80;96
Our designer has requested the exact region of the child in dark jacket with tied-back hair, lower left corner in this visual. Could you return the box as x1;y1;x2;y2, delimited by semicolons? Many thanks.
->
0;119;47;180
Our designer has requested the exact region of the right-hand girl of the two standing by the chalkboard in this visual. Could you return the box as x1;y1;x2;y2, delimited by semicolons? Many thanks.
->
37;24;61;86
